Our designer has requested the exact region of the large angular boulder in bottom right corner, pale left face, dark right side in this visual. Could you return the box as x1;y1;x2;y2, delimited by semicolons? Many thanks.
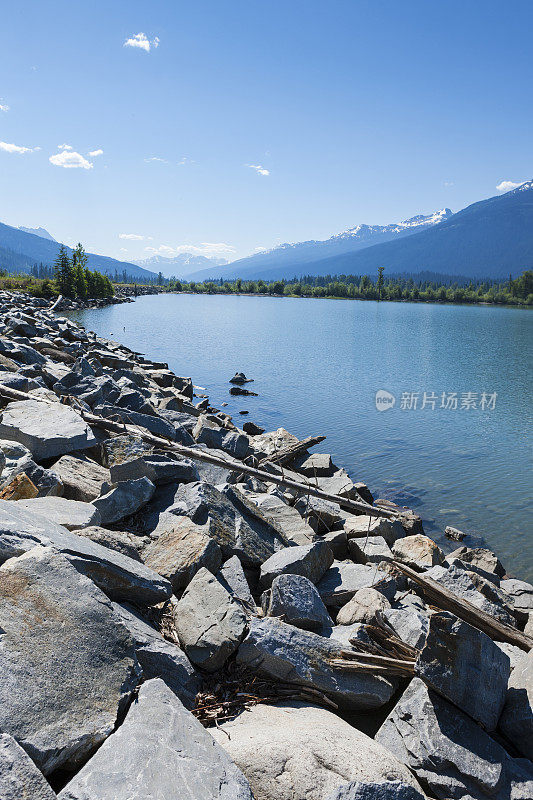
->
375;678;533;800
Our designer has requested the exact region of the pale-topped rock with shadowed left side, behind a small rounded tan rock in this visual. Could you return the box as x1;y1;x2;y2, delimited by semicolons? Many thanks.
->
317;561;396;608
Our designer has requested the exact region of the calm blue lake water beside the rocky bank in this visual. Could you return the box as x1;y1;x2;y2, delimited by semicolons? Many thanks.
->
71;294;533;580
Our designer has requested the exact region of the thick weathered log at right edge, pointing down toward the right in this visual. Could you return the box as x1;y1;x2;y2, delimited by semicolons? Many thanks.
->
392;561;533;652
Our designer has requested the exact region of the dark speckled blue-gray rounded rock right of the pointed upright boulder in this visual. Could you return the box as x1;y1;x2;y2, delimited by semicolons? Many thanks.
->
266;575;333;631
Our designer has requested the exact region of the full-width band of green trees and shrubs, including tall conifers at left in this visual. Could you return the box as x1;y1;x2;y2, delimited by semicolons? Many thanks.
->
0;238;533;306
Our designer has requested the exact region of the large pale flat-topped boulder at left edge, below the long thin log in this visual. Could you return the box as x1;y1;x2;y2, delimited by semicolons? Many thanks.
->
0;400;96;461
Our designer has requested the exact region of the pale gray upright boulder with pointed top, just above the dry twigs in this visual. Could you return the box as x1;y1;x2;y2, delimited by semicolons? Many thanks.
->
174;567;247;672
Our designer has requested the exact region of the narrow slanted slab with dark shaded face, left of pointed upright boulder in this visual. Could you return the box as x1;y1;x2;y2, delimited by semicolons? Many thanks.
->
113;603;201;708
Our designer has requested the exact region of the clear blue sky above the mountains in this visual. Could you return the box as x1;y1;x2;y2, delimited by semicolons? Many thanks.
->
0;0;533;260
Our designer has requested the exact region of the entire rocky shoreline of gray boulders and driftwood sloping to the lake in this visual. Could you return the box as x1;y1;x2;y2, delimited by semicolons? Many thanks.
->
0;292;533;800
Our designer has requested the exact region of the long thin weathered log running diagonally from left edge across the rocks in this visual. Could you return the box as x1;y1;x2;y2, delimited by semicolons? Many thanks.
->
0;386;394;519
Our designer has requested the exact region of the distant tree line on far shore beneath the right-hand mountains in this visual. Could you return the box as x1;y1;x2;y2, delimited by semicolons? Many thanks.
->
166;267;533;305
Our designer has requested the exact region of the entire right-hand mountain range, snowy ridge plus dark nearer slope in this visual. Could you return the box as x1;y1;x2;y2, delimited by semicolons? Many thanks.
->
182;181;533;281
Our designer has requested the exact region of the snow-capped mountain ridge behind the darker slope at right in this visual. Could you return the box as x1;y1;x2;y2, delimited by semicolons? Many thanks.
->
181;208;453;280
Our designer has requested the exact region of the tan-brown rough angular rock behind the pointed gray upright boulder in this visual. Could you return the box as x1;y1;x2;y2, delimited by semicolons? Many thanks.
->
143;514;222;594
